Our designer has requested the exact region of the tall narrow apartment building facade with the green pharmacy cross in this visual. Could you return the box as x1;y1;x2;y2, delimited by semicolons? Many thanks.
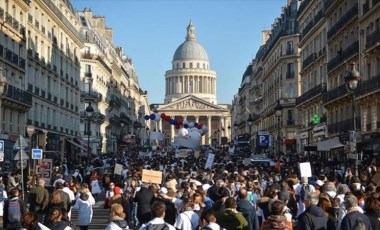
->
296;0;328;155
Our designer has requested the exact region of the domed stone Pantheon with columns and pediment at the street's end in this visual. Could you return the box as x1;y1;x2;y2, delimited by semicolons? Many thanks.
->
153;22;232;144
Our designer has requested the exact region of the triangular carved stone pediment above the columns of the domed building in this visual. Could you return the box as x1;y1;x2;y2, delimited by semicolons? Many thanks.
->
159;95;227;111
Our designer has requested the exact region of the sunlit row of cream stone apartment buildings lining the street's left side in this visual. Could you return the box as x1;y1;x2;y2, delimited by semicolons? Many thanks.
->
0;0;149;164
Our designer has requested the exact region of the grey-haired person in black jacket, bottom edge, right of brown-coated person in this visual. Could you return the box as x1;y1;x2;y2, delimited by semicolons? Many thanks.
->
297;192;327;230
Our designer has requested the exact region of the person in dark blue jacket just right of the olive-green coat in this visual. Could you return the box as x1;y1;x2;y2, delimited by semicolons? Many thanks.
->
236;188;260;230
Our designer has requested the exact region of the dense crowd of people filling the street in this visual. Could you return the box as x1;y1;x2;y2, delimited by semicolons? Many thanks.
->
0;148;380;230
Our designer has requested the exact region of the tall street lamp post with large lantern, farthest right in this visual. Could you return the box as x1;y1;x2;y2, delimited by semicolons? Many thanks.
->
344;62;360;176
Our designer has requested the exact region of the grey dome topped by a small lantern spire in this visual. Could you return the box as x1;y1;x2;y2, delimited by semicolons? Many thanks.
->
173;22;208;61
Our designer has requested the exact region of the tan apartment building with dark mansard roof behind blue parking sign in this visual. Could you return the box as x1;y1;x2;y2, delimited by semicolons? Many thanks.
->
253;1;300;155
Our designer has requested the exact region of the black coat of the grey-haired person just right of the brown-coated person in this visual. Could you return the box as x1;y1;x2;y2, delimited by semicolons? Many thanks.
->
297;205;327;230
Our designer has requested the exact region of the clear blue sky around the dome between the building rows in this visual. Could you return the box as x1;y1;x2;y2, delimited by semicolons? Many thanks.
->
71;0;287;104
